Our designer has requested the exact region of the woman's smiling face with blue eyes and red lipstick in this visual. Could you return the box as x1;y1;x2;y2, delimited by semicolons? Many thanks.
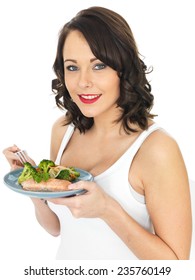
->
63;30;120;118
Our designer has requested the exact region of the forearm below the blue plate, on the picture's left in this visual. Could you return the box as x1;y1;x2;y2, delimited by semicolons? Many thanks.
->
31;198;60;236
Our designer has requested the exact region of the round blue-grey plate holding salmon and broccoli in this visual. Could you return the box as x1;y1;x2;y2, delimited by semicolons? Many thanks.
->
4;168;93;199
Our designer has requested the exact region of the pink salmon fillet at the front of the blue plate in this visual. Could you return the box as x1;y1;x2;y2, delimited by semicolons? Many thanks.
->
21;178;71;192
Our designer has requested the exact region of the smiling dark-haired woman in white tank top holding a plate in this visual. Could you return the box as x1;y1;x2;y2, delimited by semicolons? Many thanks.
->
4;7;192;260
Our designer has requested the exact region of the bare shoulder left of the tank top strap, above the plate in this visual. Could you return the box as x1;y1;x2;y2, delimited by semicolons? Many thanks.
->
50;116;68;161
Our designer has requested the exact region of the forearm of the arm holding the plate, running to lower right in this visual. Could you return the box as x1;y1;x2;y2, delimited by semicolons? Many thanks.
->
103;200;178;260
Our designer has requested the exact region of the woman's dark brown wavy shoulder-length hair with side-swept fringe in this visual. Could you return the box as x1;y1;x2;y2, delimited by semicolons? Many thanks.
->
52;7;154;134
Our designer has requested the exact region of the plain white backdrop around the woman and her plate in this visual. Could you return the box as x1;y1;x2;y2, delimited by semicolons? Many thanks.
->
0;0;195;272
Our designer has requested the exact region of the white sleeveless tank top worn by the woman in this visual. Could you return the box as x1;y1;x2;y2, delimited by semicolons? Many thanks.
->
50;124;159;260
